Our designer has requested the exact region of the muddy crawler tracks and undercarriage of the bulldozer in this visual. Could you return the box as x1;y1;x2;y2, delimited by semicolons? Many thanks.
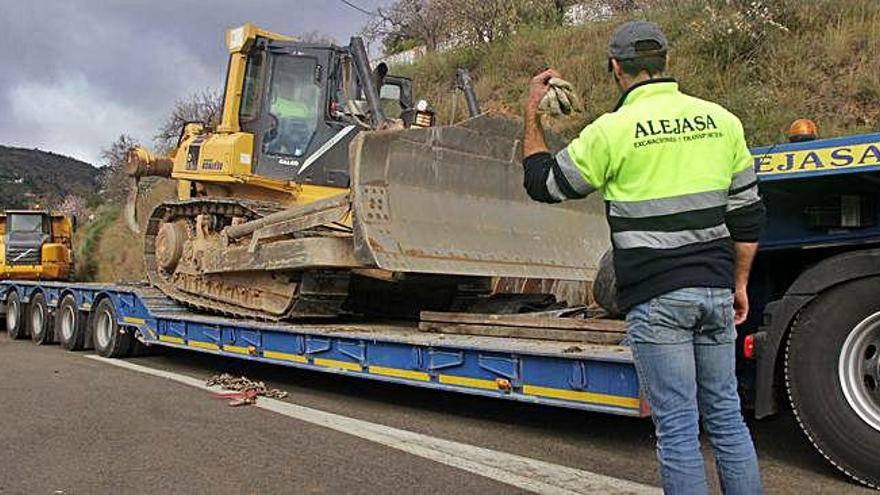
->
144;195;489;320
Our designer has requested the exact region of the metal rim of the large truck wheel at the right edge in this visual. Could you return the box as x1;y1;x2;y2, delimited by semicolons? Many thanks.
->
838;312;880;431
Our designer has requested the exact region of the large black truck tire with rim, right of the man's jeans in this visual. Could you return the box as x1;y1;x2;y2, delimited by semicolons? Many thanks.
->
785;277;880;488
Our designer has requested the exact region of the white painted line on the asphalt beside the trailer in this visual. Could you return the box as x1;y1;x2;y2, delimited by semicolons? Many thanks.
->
86;355;660;495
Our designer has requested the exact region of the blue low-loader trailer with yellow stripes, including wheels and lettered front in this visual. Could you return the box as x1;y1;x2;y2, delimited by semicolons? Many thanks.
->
0;134;880;487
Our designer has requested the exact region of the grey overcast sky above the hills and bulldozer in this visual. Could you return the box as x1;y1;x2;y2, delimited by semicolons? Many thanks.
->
0;0;386;165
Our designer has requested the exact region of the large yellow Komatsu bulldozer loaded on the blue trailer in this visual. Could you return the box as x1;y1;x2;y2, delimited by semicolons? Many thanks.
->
126;24;608;320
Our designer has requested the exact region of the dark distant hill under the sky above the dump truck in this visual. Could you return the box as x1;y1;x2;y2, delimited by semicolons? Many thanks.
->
0;146;100;209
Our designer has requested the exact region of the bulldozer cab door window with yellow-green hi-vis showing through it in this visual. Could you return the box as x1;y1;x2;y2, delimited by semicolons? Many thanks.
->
263;55;321;157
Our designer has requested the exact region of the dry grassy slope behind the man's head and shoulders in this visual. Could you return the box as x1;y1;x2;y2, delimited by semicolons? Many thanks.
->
395;0;880;145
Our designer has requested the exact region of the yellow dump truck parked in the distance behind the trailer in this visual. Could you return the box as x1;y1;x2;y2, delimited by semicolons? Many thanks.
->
0;210;73;280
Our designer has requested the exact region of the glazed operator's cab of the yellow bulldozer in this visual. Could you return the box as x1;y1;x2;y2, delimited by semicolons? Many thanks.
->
227;37;412;187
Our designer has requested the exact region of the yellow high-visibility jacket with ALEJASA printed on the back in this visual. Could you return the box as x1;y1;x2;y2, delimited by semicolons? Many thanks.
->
523;78;765;308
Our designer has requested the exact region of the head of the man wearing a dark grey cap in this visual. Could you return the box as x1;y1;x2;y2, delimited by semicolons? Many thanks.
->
608;21;669;91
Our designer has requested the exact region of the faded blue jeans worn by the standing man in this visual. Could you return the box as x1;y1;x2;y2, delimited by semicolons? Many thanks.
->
626;288;761;495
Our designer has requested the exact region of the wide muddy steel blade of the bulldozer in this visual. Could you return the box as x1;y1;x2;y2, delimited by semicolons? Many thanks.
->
351;114;609;280
